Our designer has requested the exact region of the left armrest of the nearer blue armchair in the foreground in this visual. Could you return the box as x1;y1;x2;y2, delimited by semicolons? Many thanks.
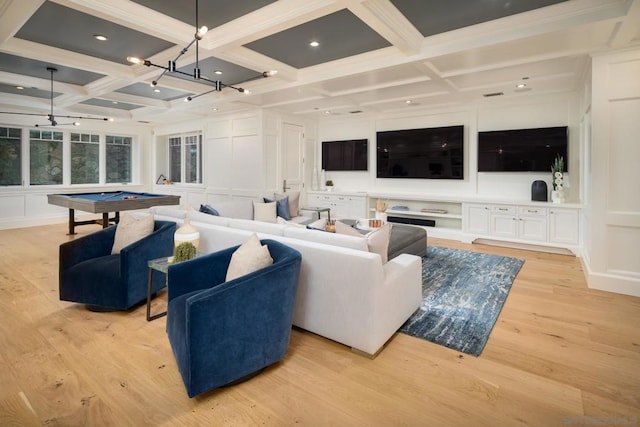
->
167;246;238;301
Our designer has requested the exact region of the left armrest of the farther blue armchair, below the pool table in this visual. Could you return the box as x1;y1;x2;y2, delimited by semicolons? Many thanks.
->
59;227;116;270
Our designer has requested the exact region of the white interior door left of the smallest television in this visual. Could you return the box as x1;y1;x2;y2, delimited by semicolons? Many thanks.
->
279;123;304;192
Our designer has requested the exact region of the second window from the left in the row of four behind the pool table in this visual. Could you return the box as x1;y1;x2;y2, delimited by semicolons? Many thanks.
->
29;130;62;185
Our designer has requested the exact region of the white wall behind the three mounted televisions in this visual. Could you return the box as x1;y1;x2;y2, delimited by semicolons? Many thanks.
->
317;94;580;203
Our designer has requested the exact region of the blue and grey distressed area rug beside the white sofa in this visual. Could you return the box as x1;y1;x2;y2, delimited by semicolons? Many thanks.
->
400;246;524;356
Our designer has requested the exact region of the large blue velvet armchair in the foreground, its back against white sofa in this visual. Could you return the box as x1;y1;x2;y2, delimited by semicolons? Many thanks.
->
167;240;301;397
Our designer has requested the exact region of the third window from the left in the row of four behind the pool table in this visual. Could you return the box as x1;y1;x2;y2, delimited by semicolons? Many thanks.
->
71;133;100;184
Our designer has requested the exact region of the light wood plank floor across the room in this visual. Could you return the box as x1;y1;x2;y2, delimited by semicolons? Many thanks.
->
0;224;640;426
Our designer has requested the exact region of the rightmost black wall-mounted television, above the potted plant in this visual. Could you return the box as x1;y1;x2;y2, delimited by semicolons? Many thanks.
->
478;126;569;172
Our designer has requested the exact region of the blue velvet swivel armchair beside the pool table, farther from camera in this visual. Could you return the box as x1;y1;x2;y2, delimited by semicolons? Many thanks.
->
58;221;176;310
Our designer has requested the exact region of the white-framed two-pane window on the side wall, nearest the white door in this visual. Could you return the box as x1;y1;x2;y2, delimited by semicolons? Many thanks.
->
169;134;202;184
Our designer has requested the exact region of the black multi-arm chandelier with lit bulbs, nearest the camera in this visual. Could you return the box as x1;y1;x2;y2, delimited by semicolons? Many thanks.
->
127;0;277;102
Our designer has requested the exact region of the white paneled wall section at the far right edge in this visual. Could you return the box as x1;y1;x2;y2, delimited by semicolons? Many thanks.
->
583;49;640;296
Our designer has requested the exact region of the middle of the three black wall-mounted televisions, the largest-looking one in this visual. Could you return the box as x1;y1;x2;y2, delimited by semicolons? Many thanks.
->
376;125;464;179
